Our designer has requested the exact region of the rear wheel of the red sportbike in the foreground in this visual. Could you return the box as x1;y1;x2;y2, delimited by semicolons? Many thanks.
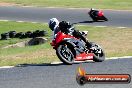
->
90;42;105;62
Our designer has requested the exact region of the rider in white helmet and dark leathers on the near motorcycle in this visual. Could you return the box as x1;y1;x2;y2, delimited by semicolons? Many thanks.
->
49;18;91;47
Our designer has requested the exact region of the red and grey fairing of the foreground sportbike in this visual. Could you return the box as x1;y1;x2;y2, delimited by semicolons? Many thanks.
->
51;32;93;61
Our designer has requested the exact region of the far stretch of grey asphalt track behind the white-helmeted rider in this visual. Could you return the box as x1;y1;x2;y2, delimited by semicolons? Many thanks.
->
0;6;132;27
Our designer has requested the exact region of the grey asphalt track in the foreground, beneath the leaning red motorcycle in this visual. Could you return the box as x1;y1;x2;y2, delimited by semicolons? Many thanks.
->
0;58;132;88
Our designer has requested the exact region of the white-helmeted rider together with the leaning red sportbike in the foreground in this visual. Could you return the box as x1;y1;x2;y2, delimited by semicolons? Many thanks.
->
49;18;105;64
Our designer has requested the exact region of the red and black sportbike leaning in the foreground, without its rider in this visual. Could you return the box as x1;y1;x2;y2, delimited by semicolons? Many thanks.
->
51;27;105;64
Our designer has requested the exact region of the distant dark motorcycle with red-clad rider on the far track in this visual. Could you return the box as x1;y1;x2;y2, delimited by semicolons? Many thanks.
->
88;8;108;22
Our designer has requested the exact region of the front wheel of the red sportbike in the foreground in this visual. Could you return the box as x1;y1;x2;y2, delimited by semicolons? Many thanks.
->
56;43;75;65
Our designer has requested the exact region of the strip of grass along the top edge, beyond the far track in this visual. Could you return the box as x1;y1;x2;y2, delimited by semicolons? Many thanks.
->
1;0;132;10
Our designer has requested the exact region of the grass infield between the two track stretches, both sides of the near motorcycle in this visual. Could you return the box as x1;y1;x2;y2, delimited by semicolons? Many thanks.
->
0;21;132;66
